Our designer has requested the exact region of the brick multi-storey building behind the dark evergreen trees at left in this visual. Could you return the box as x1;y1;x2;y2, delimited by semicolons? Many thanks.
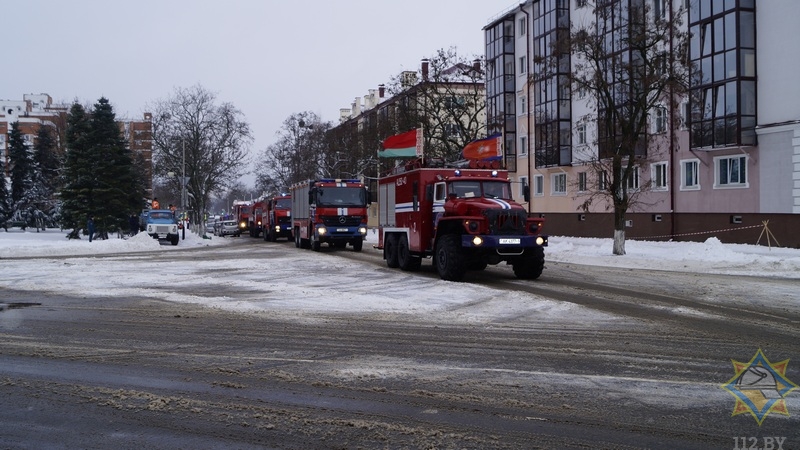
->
0;94;153;198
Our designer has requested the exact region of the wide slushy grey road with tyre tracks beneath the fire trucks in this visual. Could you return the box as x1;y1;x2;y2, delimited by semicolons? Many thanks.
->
0;238;800;449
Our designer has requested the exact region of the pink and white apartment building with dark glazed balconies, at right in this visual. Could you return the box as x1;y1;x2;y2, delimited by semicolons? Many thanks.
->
484;0;800;247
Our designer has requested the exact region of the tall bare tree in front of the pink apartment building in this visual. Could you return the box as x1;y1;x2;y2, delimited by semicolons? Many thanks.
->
552;0;688;255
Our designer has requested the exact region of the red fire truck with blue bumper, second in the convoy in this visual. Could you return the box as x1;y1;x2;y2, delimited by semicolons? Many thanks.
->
290;178;368;252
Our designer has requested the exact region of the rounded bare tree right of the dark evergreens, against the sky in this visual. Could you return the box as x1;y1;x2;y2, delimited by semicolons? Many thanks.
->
151;85;253;223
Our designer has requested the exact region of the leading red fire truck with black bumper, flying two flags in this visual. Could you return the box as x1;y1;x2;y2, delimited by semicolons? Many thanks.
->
377;162;547;281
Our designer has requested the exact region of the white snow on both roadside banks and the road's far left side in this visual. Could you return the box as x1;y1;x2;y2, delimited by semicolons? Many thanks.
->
0;229;800;323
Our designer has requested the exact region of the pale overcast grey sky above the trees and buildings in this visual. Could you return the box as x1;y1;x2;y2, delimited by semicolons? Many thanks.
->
0;0;515;184
